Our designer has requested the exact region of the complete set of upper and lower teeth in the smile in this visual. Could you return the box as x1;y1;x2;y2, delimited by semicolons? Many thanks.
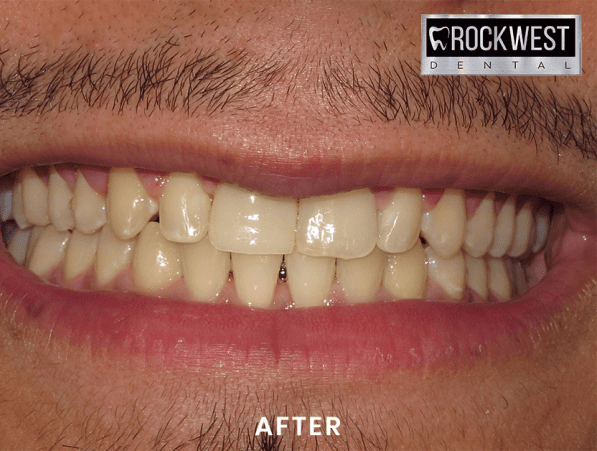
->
0;168;550;307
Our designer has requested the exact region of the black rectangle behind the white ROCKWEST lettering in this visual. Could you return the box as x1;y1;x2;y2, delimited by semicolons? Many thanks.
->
425;17;578;57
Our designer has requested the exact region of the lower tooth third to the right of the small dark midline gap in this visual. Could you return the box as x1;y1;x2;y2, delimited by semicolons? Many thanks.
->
383;241;427;299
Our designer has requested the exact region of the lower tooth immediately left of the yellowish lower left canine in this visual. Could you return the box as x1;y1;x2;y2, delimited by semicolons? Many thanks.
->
95;224;137;288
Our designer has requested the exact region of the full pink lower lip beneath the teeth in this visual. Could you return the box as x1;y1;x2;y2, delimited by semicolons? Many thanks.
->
0;217;596;374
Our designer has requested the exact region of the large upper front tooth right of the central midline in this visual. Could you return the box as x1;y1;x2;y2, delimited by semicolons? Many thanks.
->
296;189;377;259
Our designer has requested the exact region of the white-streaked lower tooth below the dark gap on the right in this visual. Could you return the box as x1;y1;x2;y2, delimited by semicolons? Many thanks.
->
425;246;466;300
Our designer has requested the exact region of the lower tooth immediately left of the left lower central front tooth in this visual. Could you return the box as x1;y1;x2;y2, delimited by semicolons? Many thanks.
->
180;235;230;300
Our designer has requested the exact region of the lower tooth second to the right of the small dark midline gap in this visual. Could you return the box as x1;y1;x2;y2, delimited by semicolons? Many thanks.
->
336;245;386;304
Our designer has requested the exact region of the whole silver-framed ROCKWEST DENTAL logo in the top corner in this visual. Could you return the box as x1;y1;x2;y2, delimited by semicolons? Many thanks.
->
421;14;581;75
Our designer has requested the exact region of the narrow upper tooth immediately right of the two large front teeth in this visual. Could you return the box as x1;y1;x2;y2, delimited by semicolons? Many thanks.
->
377;188;421;253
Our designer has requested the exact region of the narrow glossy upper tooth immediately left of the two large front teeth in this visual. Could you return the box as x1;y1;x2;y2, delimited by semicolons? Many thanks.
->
160;172;211;243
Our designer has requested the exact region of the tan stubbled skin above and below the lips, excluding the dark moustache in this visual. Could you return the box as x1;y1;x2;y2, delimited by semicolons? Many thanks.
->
0;1;597;450
